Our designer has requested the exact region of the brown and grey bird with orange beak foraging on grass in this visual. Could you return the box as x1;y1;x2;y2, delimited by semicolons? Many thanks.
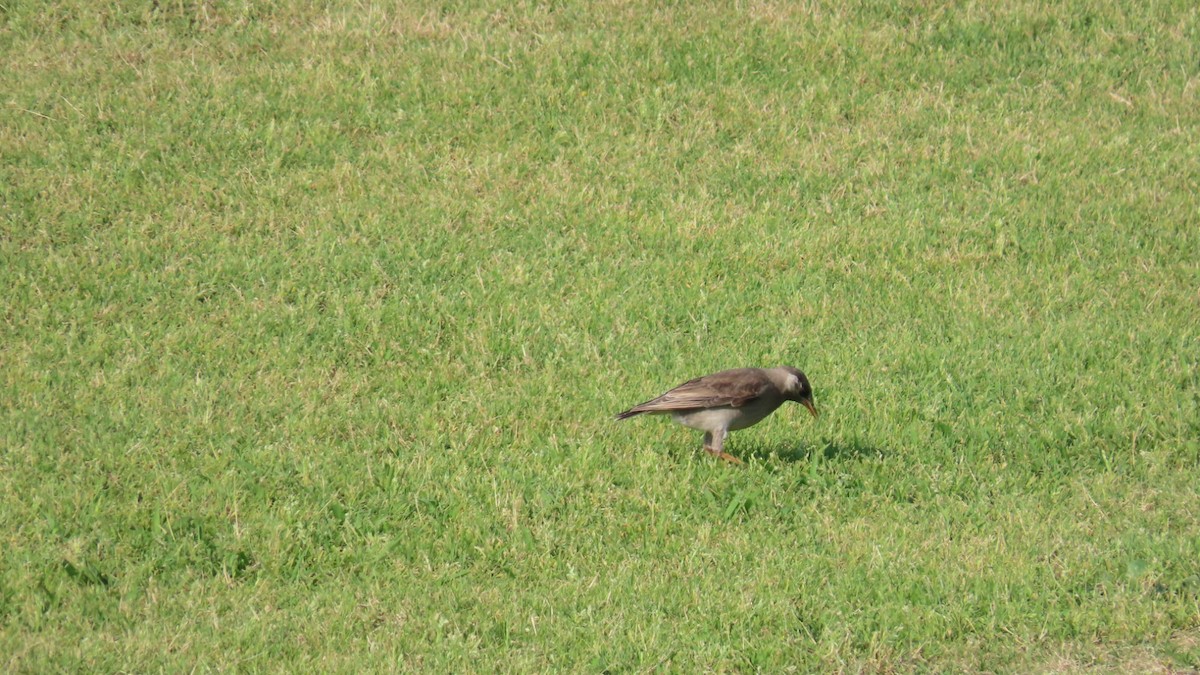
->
617;365;817;464
